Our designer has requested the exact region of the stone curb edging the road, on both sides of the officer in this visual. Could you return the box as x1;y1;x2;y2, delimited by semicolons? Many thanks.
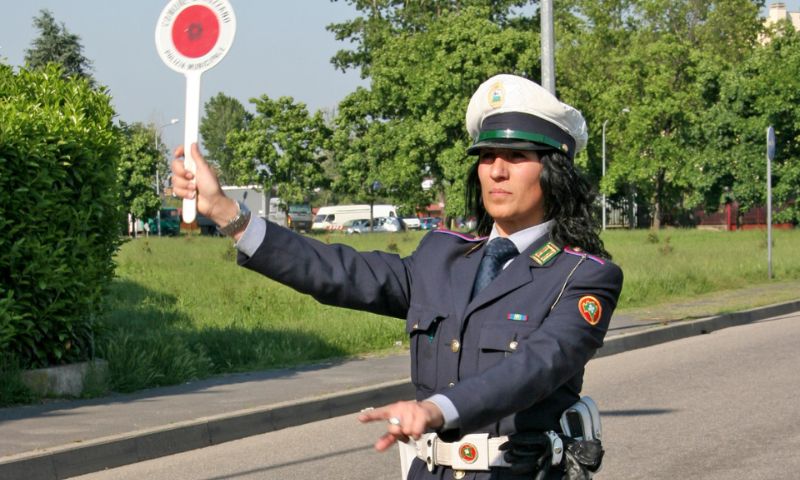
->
0;301;800;480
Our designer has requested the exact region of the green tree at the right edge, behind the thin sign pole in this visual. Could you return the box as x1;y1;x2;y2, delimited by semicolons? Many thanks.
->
700;22;800;223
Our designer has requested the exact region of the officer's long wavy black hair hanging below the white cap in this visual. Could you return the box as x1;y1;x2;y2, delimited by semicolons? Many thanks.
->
466;150;611;259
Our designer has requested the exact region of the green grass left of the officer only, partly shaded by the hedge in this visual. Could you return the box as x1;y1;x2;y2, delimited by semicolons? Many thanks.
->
99;234;421;391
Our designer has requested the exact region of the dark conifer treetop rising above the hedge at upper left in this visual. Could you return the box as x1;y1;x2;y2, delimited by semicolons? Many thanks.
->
25;9;94;84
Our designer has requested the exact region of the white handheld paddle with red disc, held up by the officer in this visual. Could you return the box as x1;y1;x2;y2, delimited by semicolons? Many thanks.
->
156;0;236;223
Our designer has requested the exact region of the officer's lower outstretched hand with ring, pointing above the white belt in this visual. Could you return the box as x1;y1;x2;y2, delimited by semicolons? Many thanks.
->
358;401;444;452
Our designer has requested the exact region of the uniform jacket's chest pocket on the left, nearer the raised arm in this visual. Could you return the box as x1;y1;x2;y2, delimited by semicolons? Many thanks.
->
406;305;447;391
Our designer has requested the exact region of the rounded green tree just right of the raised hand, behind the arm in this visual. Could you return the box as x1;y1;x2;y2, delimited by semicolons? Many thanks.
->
227;95;330;211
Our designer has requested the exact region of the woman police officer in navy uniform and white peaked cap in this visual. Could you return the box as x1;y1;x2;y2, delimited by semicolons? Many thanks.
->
172;75;622;479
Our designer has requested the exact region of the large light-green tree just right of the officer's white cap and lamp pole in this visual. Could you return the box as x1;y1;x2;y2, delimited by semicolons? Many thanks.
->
560;0;762;228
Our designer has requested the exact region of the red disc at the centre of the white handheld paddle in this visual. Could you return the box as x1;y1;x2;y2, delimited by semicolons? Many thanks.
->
172;5;219;58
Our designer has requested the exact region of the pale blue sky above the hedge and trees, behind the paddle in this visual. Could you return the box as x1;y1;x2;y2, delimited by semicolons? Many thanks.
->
0;0;365;147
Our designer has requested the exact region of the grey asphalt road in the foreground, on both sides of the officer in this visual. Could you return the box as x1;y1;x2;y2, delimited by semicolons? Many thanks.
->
72;314;800;480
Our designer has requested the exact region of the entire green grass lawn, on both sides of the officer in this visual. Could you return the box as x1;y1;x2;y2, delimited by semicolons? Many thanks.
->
86;230;800;398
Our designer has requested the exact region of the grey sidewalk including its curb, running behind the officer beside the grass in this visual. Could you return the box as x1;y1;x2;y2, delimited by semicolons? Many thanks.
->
0;301;800;480
